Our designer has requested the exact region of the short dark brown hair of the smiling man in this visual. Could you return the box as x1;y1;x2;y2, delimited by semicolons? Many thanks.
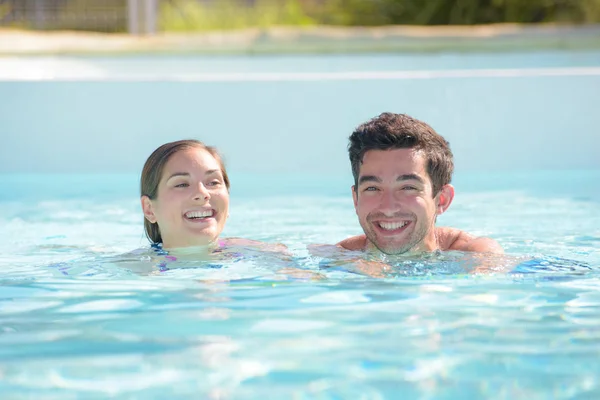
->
348;113;454;196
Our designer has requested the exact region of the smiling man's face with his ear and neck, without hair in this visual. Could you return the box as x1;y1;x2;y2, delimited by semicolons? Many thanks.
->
352;149;454;254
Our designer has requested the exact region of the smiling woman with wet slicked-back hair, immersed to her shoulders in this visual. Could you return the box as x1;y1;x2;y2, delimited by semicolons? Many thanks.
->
140;140;285;261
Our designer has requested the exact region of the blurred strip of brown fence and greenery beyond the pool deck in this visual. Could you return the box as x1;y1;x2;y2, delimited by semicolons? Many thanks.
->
0;0;600;33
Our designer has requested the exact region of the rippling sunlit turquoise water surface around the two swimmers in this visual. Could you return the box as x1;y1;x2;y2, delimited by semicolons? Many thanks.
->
0;171;600;400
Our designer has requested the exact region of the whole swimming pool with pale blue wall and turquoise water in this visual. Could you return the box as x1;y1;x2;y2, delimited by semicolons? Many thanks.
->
0;52;600;399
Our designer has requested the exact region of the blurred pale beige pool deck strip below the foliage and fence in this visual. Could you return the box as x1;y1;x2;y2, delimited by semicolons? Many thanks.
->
0;24;600;56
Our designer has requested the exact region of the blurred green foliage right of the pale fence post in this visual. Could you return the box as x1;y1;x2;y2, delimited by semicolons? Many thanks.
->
161;0;600;31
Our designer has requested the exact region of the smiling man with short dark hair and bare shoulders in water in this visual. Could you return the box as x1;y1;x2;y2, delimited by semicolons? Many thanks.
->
338;113;503;255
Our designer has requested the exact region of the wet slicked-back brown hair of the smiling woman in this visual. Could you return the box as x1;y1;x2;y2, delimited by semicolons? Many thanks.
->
140;139;229;243
